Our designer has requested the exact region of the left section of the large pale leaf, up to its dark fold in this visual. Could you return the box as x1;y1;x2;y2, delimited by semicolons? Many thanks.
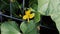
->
38;0;49;15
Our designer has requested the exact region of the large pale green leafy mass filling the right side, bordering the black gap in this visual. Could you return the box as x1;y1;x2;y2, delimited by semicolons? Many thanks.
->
38;0;60;32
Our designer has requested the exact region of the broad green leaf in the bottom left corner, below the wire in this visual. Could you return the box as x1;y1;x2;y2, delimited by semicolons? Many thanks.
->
1;21;20;34
